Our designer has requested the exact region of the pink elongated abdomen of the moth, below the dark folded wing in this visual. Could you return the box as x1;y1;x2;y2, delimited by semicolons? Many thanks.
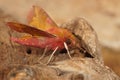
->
10;37;64;50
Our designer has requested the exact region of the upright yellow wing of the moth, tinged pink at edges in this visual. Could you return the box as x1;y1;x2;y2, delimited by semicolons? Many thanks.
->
28;6;57;31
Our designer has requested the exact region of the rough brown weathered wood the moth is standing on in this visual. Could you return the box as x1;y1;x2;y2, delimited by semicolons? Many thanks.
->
0;9;120;80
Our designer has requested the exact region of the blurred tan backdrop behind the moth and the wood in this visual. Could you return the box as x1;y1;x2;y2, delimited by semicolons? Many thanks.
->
0;0;120;76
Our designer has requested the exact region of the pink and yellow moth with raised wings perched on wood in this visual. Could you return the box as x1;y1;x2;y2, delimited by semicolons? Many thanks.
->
7;6;76;62
